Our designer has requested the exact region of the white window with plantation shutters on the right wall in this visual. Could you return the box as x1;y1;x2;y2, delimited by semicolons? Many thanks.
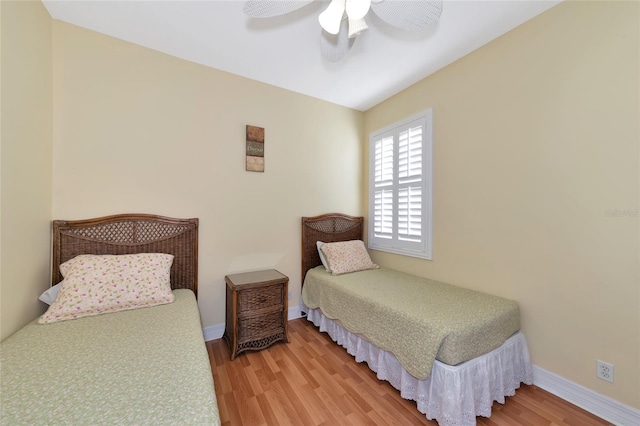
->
369;108;433;259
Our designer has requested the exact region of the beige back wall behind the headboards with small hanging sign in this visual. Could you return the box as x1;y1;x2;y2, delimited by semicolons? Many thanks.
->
53;21;363;327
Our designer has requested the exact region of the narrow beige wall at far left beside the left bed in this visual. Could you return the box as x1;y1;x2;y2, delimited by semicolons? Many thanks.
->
0;1;53;340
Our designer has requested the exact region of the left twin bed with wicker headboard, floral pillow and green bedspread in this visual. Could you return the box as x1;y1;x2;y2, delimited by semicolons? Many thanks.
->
0;215;220;425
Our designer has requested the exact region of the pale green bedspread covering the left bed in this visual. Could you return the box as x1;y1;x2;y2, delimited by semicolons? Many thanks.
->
0;290;220;425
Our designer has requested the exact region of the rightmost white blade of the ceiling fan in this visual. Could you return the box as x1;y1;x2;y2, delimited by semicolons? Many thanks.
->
371;0;442;30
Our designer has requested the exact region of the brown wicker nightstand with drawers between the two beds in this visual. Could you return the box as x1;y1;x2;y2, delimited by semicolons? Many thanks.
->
224;269;289;359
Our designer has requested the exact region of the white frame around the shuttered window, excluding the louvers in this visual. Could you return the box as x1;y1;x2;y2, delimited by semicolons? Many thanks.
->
367;108;433;260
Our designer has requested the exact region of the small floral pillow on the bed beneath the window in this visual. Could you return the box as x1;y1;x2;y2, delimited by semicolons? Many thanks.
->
320;240;378;275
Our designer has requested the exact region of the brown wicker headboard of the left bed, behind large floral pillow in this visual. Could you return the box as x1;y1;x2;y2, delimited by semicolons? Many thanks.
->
51;214;198;296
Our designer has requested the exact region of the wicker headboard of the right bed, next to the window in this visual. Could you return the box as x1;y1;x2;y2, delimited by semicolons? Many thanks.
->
301;213;364;285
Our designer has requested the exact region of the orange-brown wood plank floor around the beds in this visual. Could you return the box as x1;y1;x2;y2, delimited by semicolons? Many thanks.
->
207;318;609;426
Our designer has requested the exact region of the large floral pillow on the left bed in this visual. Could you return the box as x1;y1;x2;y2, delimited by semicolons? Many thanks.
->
38;253;174;324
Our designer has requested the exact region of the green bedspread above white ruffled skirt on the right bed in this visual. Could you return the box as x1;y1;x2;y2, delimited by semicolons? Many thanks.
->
302;266;520;380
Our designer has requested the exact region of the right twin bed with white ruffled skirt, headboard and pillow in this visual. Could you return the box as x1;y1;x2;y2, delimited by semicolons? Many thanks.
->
302;214;533;426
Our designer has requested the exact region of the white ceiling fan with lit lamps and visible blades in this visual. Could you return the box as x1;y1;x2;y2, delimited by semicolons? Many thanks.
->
243;0;442;62
